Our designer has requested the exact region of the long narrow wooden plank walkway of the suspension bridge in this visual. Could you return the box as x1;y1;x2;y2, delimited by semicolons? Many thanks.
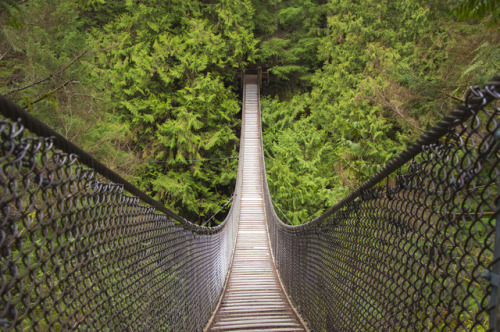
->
208;75;306;331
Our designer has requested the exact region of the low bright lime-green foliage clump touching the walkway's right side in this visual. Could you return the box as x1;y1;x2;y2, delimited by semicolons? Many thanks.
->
262;95;344;224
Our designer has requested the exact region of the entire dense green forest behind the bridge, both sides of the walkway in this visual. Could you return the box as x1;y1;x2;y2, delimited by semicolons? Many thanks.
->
0;0;500;224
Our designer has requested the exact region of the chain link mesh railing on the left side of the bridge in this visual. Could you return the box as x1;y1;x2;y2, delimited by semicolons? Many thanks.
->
0;97;241;331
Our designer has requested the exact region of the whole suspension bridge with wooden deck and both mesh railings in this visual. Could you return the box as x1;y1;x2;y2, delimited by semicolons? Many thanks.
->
0;75;500;331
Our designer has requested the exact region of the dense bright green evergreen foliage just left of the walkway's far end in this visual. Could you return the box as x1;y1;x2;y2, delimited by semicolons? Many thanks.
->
86;1;255;222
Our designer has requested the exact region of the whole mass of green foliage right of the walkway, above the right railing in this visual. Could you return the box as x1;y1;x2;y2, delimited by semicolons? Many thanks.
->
260;0;498;223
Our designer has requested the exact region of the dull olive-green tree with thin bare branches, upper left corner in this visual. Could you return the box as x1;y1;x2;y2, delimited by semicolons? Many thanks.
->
0;0;134;171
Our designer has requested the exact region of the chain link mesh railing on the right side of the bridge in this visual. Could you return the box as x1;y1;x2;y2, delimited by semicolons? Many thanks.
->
263;77;500;331
